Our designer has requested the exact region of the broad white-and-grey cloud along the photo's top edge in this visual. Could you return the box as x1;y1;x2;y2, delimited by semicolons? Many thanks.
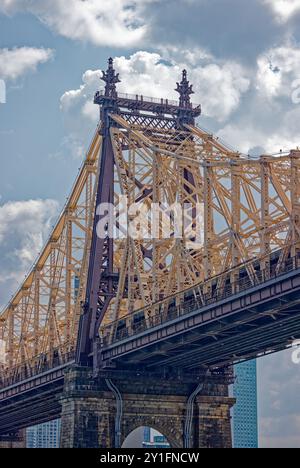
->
0;0;290;59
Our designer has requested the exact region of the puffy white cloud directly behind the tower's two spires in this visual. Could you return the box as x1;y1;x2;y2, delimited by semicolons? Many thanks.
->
61;48;250;122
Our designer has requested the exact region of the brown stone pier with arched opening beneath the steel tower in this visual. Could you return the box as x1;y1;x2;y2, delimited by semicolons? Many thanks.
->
61;367;235;448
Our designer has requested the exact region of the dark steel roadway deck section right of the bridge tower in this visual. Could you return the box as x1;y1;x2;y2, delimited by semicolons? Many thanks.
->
102;269;300;369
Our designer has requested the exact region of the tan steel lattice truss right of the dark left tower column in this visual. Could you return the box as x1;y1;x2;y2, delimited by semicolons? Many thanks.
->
99;115;300;339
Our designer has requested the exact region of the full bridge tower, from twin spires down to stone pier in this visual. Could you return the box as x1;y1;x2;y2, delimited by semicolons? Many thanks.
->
61;59;234;448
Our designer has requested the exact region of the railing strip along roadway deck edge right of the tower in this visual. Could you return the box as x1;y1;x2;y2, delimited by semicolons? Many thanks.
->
101;251;300;347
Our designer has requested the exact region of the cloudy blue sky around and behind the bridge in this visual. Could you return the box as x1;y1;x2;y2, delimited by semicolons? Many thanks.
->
0;0;300;446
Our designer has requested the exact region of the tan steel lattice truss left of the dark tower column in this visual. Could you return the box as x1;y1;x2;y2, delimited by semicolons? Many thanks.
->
0;132;101;379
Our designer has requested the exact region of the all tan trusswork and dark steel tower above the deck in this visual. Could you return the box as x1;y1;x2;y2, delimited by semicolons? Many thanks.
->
0;56;300;382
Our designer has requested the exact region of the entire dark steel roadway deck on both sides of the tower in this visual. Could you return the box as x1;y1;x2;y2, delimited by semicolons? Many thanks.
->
0;262;300;435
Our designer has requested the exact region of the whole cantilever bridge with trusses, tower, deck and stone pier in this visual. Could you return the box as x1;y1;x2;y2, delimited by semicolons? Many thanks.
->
0;59;300;448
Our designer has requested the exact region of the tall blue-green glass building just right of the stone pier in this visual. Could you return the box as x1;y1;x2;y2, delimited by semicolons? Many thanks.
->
233;361;258;448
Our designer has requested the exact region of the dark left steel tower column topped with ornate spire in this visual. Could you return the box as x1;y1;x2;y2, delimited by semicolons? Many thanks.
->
76;59;120;374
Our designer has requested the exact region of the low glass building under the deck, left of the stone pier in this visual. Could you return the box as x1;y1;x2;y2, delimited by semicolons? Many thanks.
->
26;420;60;448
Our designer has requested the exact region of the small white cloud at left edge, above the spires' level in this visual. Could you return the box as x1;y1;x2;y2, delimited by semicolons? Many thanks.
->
0;47;53;80
